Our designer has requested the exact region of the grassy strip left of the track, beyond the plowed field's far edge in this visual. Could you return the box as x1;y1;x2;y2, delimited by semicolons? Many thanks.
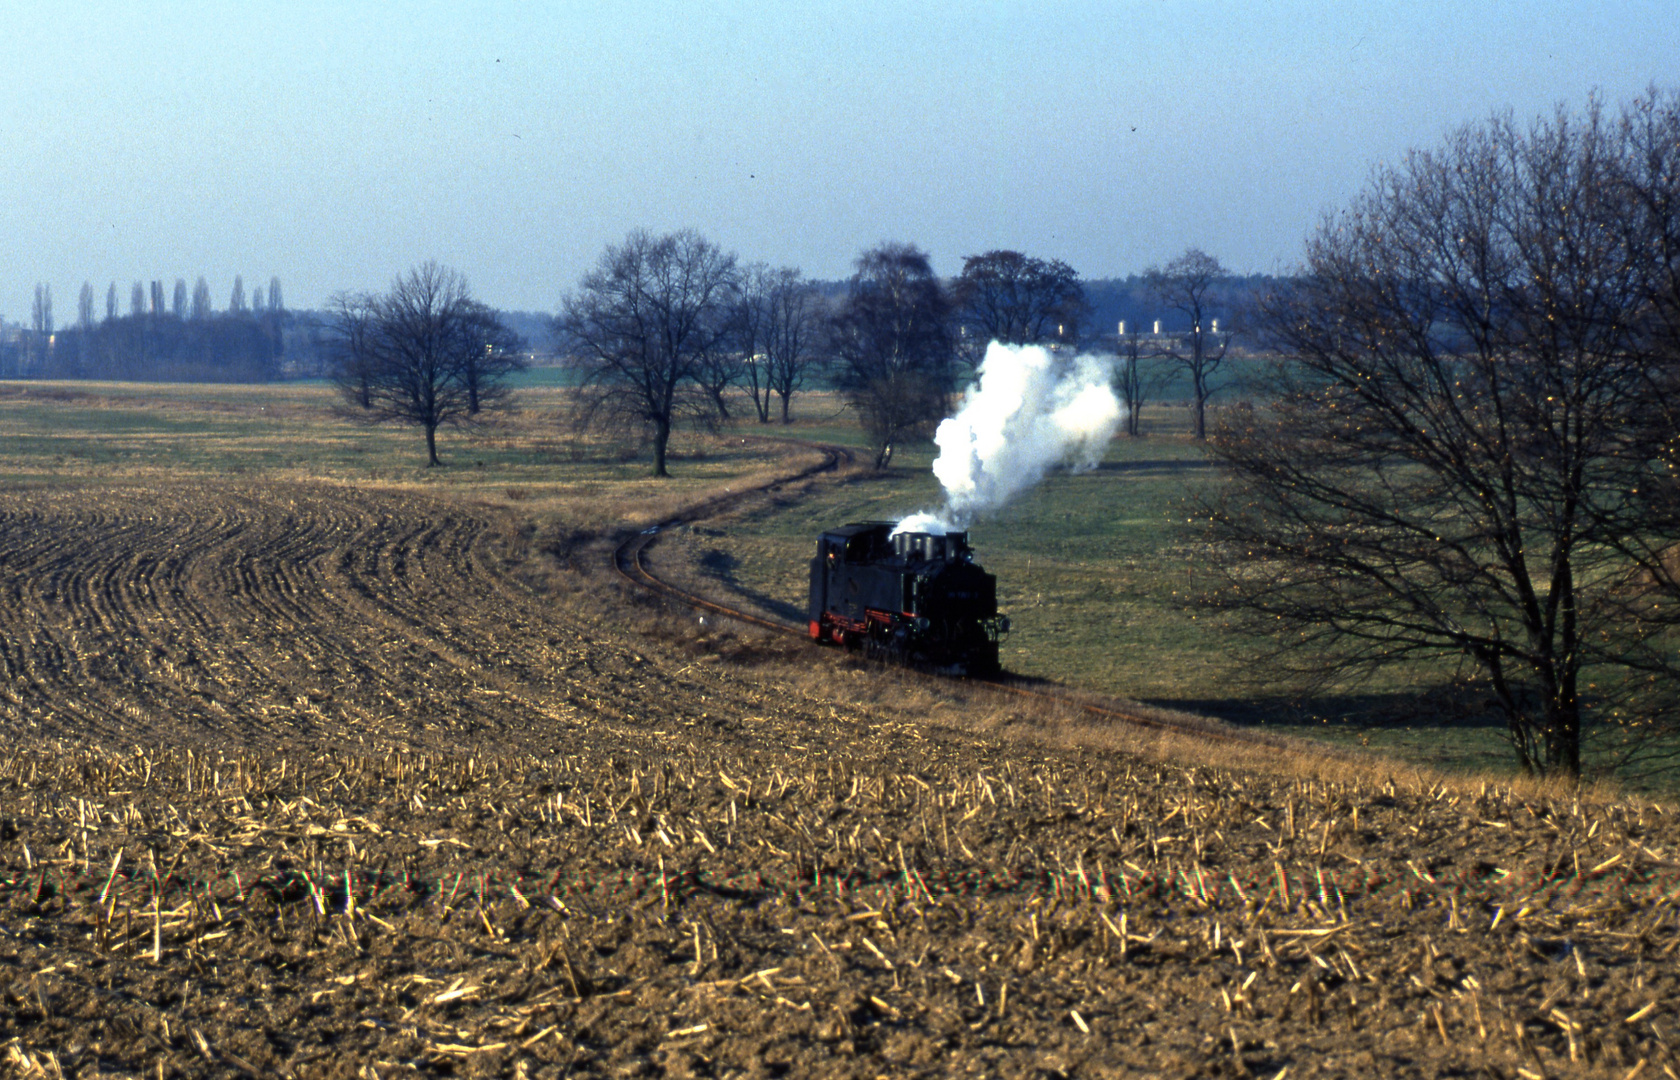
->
0;383;819;529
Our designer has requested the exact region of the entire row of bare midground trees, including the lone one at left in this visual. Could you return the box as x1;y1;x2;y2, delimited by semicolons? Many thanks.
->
326;230;1230;475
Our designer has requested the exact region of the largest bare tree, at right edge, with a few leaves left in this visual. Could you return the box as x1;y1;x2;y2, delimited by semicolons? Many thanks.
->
1208;99;1680;776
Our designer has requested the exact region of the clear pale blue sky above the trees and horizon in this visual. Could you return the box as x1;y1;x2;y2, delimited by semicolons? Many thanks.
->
0;0;1680;317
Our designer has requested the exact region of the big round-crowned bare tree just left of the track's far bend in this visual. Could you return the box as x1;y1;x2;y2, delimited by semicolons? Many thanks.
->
554;230;736;477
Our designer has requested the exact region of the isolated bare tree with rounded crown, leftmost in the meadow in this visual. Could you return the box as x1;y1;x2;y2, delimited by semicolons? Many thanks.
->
325;262;506;467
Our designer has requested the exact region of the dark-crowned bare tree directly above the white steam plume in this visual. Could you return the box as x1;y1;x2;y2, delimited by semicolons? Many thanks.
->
951;250;1090;368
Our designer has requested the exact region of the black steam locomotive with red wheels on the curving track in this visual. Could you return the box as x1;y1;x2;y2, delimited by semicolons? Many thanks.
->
810;521;1010;675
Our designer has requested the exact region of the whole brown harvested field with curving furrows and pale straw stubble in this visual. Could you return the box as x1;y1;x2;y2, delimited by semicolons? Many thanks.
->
0;484;1680;1077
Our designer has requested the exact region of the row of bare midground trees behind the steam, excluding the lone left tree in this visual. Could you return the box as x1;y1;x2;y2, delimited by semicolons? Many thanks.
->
554;230;1228;475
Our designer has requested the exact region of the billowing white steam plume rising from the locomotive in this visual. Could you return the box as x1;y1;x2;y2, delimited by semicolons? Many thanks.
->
895;341;1126;534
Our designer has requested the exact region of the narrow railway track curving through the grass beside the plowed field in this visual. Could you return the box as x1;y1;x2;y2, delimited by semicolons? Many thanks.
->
613;443;1270;744
